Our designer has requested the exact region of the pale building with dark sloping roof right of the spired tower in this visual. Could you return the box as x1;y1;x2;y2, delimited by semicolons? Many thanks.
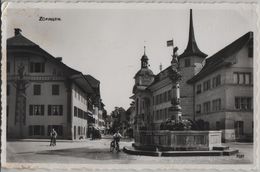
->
188;32;253;141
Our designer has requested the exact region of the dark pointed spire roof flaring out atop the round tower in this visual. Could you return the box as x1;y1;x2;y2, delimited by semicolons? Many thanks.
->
179;9;207;59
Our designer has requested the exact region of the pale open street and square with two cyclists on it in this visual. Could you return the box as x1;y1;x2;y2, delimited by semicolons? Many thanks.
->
7;138;253;164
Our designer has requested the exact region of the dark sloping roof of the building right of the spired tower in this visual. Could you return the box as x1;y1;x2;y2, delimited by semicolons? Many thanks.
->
187;32;253;84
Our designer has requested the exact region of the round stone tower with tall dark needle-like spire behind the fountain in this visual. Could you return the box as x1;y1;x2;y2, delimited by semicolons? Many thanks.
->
179;9;207;119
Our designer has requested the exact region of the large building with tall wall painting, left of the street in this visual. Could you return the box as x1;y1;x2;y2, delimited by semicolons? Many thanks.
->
7;29;103;139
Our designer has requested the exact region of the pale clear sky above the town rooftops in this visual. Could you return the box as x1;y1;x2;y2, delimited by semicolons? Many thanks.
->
4;4;256;113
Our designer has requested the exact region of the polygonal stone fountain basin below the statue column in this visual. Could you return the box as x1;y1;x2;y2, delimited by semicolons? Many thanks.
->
133;130;222;151
